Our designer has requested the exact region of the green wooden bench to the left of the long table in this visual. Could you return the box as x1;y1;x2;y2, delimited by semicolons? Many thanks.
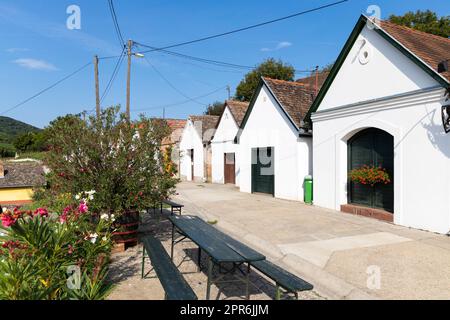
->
142;236;197;300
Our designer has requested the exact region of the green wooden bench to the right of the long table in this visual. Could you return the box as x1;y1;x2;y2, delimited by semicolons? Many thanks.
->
251;260;314;300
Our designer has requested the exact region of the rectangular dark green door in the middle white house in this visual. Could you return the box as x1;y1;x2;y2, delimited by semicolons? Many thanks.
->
252;148;275;195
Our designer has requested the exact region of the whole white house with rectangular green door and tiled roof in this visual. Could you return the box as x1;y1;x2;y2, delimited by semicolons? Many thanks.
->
237;78;314;201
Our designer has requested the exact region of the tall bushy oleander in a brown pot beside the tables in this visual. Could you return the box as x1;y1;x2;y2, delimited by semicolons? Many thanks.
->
39;107;178;248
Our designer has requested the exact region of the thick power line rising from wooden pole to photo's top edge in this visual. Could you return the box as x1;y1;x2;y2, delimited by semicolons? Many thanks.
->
137;0;349;53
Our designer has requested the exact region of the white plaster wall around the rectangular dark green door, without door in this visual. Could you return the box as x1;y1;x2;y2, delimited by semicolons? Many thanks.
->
239;87;310;201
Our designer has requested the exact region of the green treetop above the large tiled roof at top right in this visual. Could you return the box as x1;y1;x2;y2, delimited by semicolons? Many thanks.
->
389;10;450;38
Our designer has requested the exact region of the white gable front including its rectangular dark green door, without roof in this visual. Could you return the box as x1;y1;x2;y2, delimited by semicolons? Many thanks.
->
238;85;312;201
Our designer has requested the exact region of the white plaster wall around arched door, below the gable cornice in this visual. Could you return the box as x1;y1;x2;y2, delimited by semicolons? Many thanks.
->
313;90;450;233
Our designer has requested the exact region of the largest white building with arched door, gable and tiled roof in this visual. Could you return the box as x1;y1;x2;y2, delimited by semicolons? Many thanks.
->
311;16;450;233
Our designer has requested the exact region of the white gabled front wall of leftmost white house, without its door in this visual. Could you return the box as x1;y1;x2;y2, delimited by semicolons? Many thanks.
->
180;120;205;181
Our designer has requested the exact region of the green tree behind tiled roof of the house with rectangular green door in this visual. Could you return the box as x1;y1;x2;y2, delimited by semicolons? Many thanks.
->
235;58;295;101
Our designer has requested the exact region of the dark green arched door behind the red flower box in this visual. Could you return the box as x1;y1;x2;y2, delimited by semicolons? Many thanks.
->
348;128;394;213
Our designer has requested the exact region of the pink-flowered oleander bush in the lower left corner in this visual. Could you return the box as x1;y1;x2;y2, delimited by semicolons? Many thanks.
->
0;199;112;300
